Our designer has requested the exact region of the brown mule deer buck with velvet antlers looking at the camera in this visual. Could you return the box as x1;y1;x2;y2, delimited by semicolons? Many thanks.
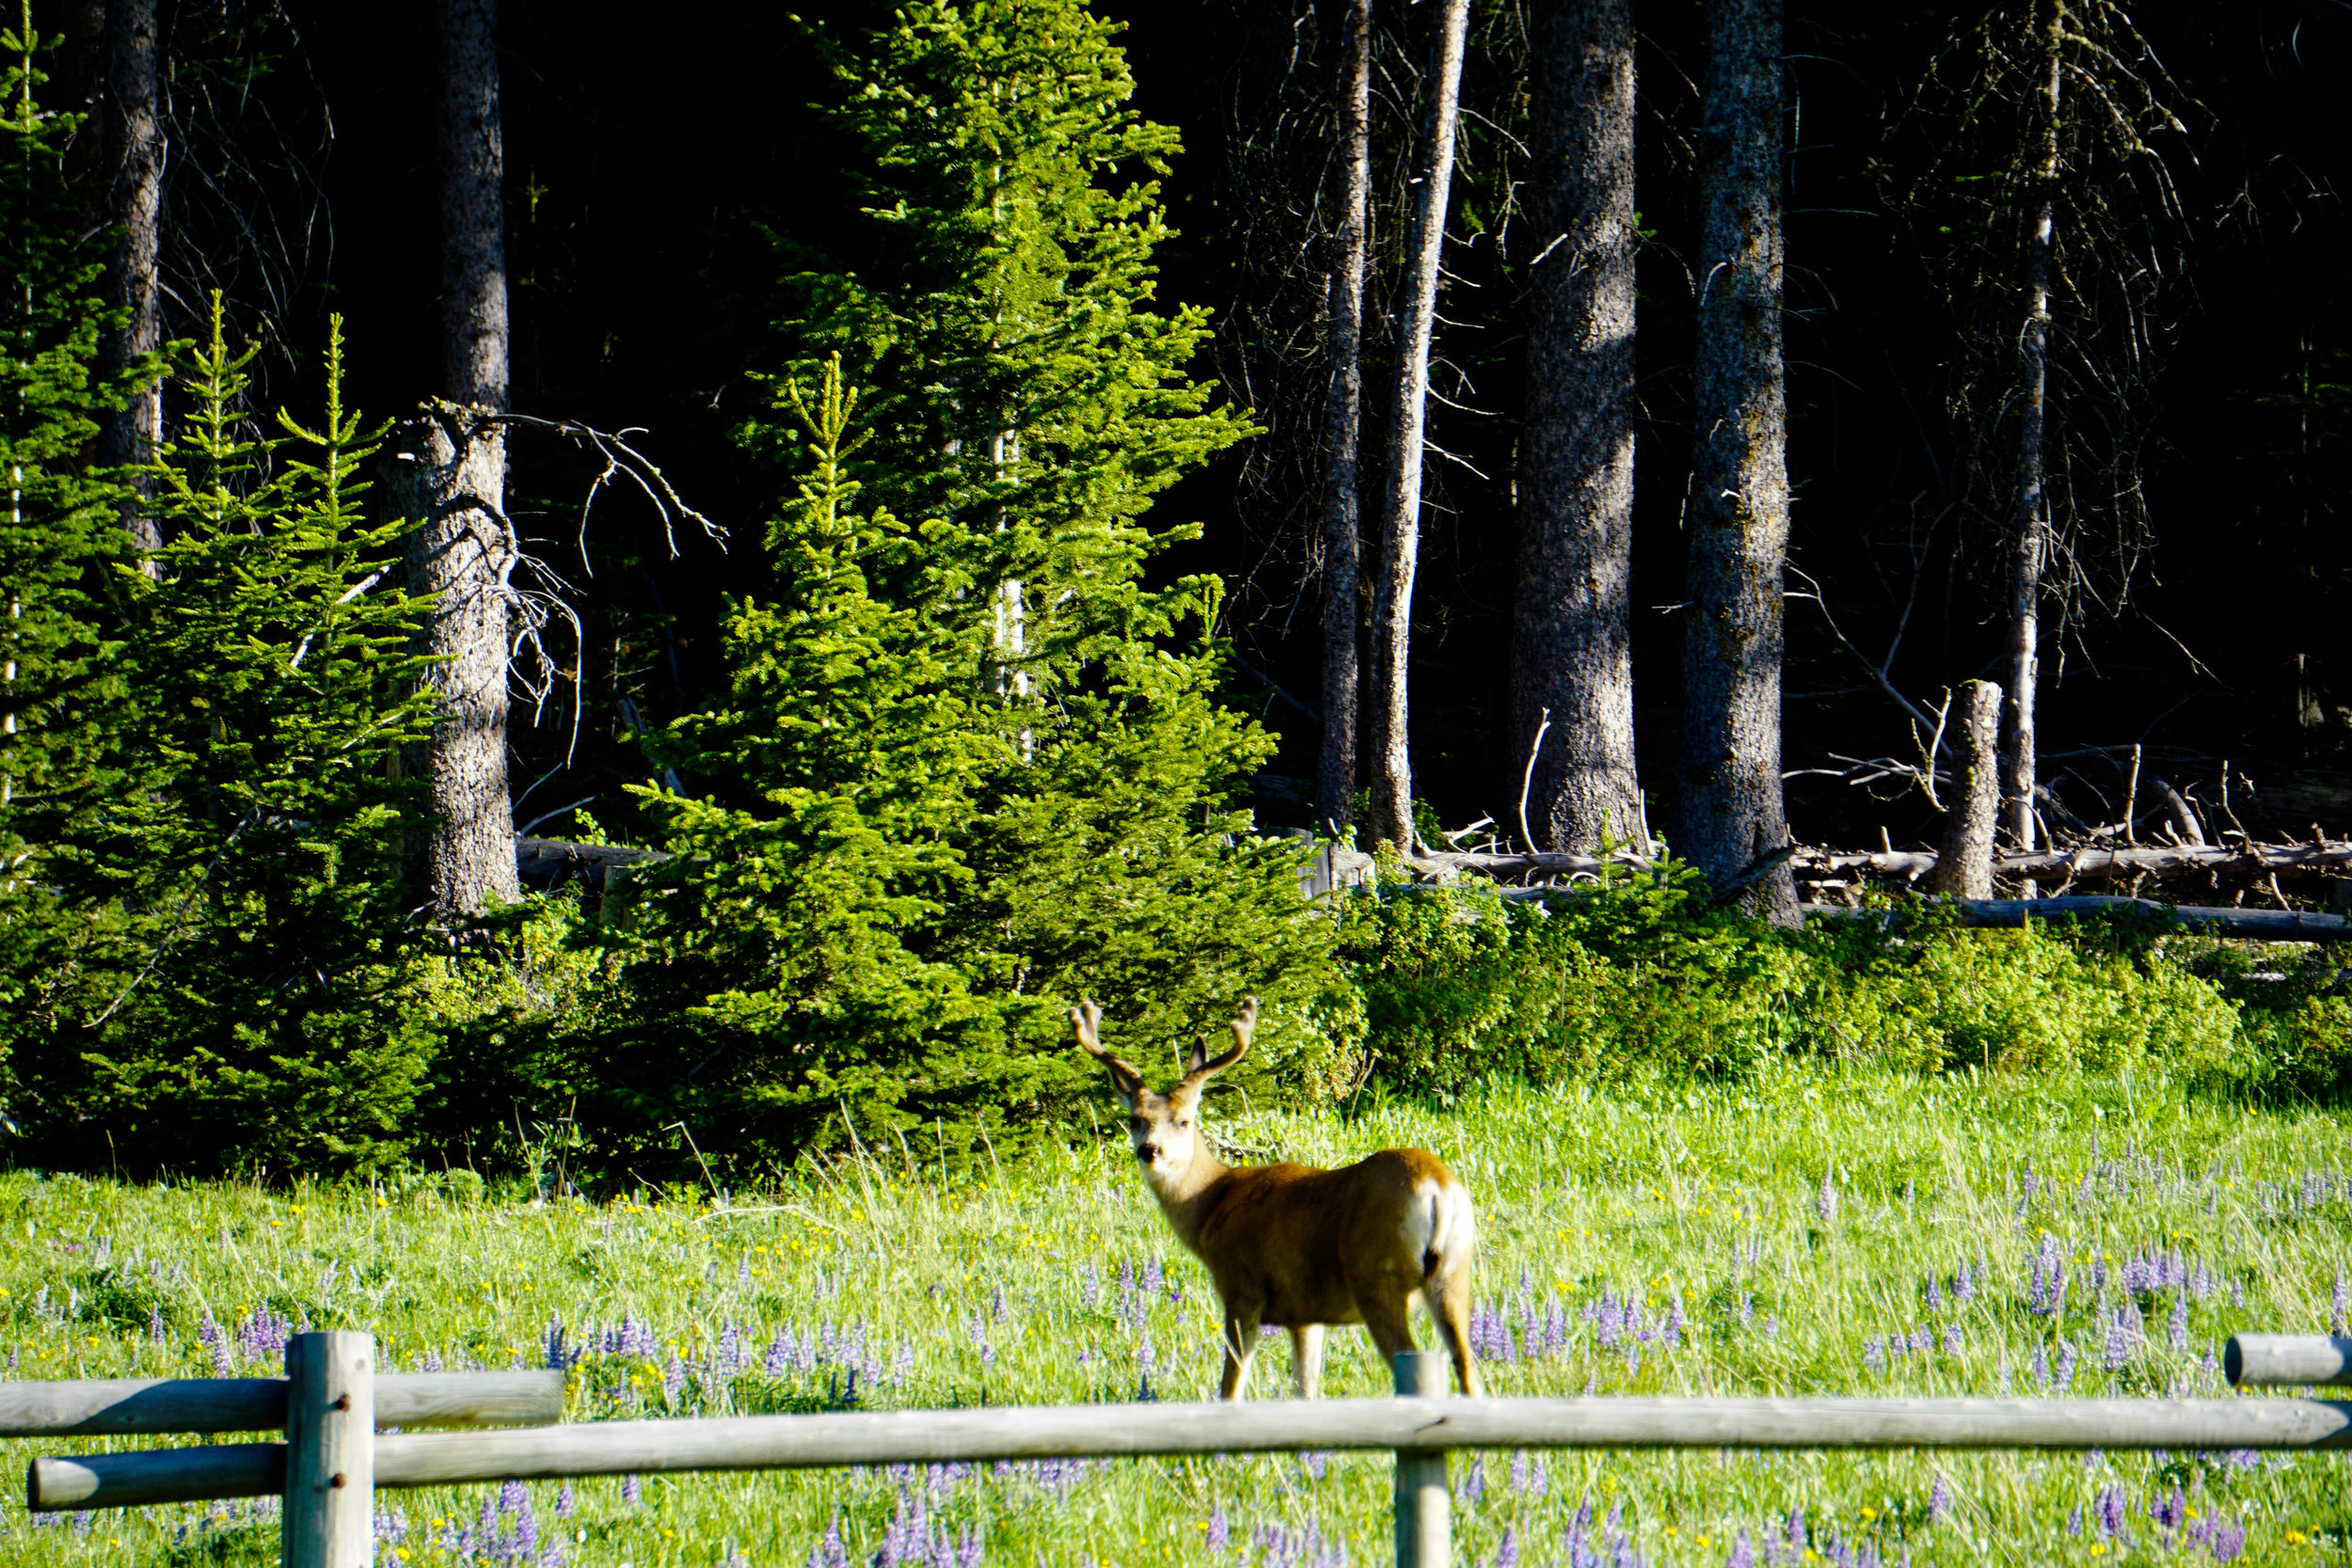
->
1071;997;1485;1399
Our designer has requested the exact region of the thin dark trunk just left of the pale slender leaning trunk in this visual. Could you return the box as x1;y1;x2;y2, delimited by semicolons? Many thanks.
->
1315;0;1372;830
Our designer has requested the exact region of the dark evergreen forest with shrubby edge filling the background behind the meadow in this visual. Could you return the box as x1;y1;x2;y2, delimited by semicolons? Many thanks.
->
0;0;2352;1189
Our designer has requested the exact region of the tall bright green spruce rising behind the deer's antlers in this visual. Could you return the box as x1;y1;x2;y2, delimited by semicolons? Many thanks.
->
564;0;1345;1157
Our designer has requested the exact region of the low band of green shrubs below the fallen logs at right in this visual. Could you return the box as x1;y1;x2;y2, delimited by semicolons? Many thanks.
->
1343;863;2267;1101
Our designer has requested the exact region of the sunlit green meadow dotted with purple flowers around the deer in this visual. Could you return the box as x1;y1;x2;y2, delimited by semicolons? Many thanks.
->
0;1069;2352;1568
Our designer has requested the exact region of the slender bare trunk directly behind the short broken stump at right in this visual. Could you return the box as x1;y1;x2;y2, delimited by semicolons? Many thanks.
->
2002;0;2065;879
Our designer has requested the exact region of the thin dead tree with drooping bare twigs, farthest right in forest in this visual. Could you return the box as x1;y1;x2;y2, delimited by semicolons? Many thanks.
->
1886;0;2209;891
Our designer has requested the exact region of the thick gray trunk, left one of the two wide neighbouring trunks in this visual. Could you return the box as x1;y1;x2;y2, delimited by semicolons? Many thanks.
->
1510;0;1642;851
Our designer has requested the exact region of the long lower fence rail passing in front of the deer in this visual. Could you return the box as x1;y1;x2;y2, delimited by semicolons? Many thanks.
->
31;1399;2352;1512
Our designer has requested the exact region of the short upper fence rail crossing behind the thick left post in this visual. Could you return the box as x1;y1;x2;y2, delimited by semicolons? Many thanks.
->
0;1370;564;1436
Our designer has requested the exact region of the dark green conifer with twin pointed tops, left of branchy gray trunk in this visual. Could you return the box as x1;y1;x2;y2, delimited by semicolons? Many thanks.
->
17;296;433;1171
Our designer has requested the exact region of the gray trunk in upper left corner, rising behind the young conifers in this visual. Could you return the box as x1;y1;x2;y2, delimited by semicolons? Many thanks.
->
99;0;165;566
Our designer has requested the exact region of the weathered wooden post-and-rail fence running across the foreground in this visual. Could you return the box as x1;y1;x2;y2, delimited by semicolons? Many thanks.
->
18;1333;2352;1568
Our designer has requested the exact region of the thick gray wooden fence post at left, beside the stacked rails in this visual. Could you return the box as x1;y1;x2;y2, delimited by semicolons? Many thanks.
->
280;1333;376;1568
